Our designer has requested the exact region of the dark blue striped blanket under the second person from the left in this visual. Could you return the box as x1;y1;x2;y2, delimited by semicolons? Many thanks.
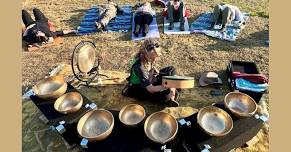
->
77;5;132;35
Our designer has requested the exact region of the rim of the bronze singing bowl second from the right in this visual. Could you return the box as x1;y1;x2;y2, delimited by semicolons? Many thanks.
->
197;106;233;137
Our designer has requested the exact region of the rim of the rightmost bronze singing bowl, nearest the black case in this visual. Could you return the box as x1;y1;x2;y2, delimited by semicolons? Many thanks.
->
223;91;258;117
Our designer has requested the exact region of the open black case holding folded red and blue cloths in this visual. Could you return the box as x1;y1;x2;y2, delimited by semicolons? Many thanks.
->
226;61;264;103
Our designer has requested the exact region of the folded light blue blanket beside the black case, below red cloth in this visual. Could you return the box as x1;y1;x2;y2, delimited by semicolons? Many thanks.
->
235;78;268;92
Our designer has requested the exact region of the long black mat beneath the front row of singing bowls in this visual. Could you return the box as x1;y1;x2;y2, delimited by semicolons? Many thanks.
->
56;104;263;152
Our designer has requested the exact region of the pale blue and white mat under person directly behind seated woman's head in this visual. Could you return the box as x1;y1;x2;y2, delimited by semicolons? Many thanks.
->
131;13;160;40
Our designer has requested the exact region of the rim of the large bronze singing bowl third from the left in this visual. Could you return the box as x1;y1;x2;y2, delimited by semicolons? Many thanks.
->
77;109;114;140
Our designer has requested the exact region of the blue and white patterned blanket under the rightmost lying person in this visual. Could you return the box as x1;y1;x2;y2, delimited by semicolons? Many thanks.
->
190;12;249;41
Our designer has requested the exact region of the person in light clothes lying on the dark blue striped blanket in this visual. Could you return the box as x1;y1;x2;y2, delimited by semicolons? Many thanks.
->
96;0;123;32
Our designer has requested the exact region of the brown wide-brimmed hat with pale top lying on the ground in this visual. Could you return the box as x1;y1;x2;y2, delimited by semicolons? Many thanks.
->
199;72;222;86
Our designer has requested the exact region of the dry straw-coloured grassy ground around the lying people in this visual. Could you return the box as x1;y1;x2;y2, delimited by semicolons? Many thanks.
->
22;0;269;151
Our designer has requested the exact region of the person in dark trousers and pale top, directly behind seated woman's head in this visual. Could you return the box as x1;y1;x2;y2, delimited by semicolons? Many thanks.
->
133;2;156;37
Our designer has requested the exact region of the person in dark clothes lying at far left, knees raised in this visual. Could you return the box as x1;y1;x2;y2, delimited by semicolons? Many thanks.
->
22;8;76;46
